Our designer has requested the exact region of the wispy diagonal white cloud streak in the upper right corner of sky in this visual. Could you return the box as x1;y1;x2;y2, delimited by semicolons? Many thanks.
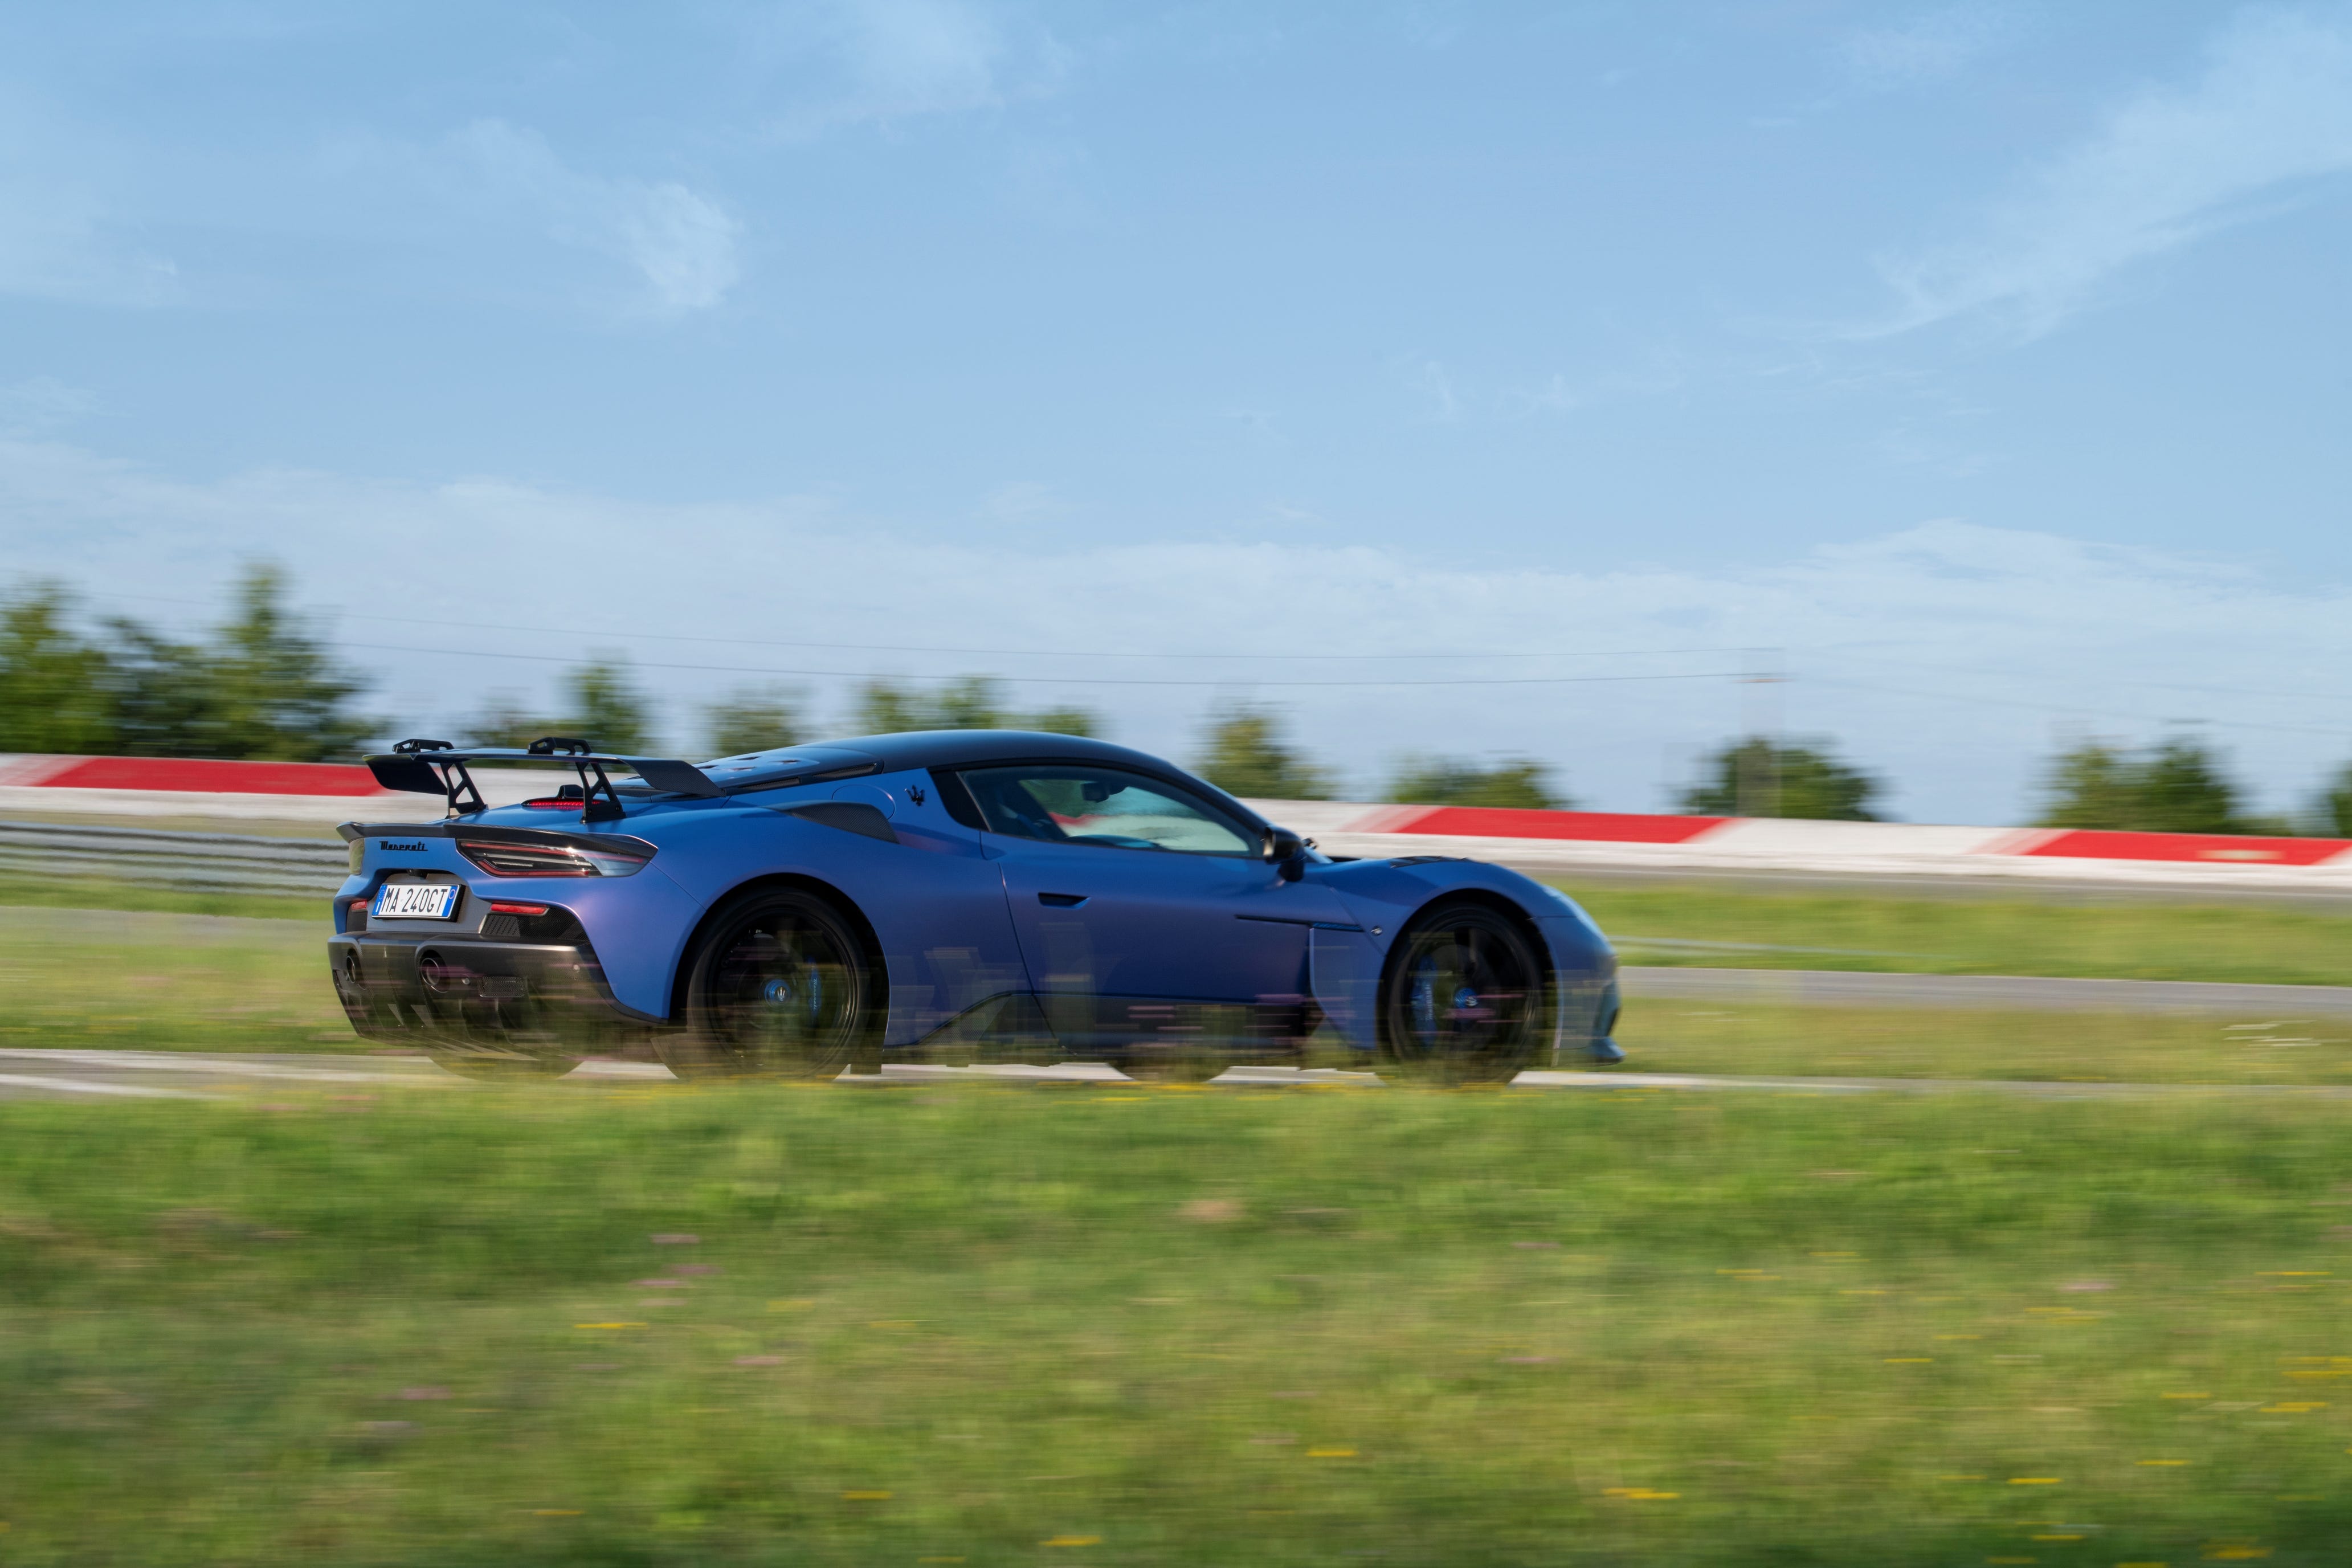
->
1853;10;2352;336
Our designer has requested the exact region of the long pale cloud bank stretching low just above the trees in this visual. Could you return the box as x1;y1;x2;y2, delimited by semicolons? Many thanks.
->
0;440;2352;823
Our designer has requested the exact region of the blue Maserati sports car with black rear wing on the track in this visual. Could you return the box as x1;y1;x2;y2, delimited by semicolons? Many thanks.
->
327;731;1618;1081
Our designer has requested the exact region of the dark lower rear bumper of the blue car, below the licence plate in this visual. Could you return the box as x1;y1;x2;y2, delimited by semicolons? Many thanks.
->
327;931;654;1051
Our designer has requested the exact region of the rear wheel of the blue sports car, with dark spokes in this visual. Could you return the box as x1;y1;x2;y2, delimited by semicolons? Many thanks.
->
659;889;884;1079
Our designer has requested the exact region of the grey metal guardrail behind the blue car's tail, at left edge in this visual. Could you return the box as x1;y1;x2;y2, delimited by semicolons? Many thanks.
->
0;823;350;898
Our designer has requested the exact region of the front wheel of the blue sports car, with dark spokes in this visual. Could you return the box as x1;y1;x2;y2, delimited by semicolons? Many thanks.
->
1381;903;1552;1084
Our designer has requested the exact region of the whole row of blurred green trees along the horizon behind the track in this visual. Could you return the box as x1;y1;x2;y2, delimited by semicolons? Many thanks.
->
0;564;2352;837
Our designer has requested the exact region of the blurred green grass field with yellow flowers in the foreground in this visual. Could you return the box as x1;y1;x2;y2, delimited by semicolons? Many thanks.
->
0;1088;2352;1568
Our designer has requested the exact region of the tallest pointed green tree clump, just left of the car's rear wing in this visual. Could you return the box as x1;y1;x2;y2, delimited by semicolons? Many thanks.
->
106;564;376;762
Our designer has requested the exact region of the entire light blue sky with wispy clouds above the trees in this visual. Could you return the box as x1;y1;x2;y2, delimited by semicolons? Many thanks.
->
0;0;2352;823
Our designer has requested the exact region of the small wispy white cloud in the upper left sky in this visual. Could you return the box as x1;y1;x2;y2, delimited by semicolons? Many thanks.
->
452;120;741;315
